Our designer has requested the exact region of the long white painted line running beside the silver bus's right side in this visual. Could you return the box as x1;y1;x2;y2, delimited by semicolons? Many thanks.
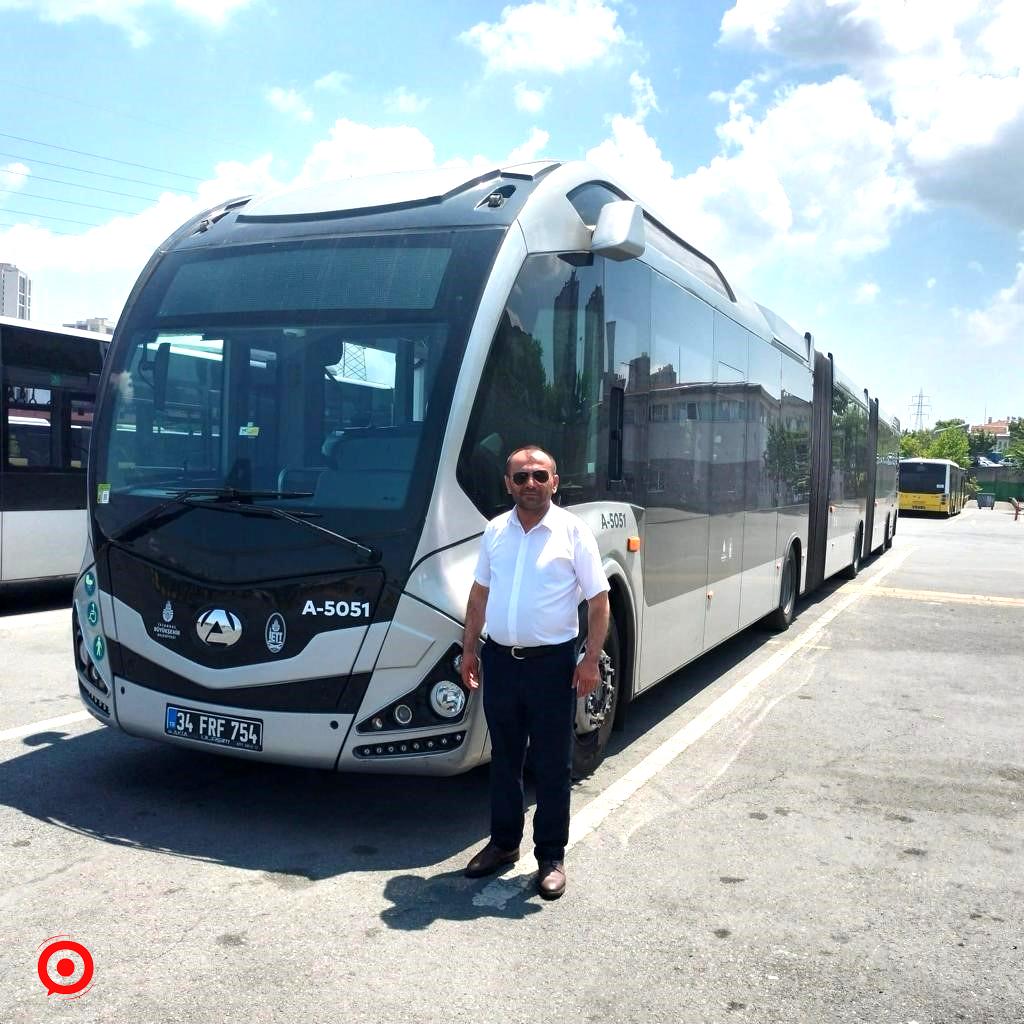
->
473;548;915;909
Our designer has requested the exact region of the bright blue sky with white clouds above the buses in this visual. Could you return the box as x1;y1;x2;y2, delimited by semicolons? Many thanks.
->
0;0;1024;426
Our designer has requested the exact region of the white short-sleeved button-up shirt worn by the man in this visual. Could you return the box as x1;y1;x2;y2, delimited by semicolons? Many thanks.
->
474;505;609;647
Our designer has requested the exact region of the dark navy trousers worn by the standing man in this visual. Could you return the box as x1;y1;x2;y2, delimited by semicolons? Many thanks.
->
481;640;577;860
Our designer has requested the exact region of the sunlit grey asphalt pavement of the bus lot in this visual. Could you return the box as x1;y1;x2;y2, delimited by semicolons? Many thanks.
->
0;506;1024;1024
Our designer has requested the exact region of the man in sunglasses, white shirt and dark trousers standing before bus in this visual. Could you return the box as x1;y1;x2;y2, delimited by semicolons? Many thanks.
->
462;444;608;899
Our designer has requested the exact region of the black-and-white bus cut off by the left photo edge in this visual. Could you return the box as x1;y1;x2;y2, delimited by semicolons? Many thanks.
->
0;316;110;584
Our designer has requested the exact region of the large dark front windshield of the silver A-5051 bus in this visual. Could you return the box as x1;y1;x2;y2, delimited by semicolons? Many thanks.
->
93;230;500;573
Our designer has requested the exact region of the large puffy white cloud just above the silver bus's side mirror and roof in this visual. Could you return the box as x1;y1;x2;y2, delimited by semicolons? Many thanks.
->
588;78;916;276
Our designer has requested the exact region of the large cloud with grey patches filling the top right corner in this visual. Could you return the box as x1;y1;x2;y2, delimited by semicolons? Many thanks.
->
721;0;1024;227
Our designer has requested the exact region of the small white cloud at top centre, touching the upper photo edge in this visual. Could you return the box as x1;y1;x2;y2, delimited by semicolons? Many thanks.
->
459;0;626;75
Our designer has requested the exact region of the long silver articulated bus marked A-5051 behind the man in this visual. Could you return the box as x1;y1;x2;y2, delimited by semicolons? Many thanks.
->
74;162;899;775
